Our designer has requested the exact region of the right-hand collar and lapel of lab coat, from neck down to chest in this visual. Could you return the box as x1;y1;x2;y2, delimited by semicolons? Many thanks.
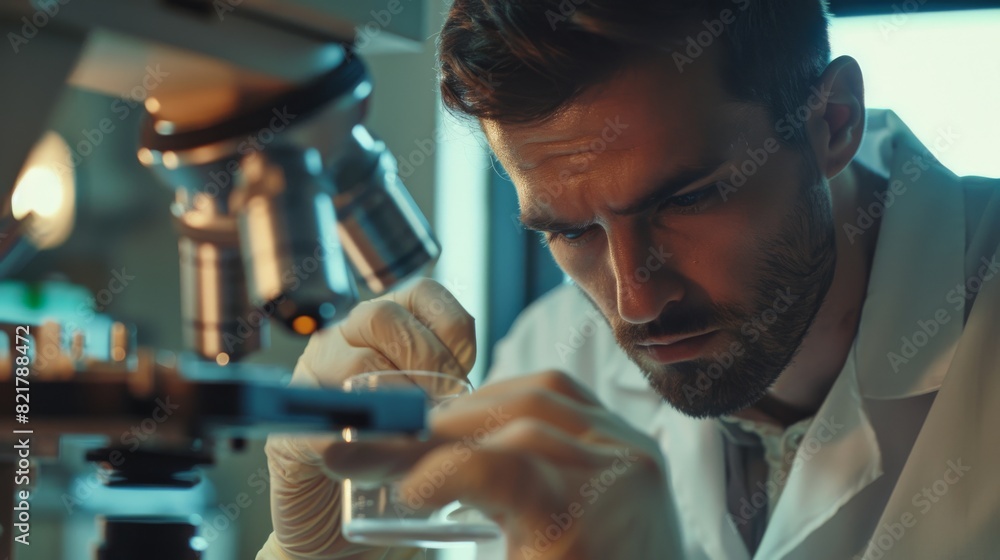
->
755;111;965;560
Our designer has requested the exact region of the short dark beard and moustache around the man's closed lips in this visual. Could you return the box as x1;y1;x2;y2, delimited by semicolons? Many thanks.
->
588;176;837;418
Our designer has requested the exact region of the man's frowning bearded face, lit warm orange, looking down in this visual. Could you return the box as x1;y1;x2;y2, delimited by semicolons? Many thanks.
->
483;53;835;417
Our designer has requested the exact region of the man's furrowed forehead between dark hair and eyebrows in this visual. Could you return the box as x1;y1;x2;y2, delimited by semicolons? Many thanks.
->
483;51;745;184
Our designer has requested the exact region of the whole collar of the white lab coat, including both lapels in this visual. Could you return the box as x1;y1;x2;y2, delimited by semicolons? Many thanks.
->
617;111;965;560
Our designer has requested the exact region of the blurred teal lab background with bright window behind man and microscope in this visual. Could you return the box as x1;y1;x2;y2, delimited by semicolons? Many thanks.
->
0;0;1000;560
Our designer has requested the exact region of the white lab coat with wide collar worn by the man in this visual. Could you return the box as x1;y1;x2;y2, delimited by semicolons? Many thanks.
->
479;111;1000;560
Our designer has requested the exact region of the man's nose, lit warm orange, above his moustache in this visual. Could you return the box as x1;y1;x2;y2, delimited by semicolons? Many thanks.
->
610;230;684;324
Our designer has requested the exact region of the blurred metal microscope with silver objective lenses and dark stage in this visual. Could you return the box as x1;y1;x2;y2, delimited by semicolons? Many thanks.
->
0;0;440;560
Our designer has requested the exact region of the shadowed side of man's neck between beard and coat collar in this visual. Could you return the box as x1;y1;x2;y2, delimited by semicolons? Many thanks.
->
736;162;887;426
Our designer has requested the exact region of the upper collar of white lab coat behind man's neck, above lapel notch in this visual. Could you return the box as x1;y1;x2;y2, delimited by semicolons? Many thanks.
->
855;111;965;399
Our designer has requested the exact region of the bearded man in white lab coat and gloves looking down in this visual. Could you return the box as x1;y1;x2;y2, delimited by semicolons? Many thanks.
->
260;0;1000;560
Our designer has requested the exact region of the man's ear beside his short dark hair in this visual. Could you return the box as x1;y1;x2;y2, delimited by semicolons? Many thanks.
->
809;56;865;179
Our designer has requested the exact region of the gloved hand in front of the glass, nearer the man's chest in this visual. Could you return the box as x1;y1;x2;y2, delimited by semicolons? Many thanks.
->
326;371;684;560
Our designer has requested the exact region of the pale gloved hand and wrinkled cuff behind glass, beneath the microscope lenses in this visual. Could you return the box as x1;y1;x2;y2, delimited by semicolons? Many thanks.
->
257;279;476;560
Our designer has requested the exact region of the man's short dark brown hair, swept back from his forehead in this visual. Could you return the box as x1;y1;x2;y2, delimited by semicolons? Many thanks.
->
438;0;830;144
